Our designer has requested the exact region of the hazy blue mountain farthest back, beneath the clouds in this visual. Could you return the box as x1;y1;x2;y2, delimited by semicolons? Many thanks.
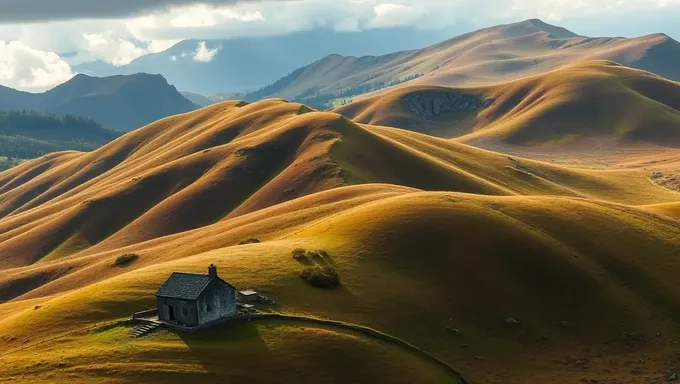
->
74;27;468;95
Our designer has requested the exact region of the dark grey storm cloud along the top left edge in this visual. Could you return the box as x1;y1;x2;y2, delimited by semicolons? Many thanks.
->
0;0;257;23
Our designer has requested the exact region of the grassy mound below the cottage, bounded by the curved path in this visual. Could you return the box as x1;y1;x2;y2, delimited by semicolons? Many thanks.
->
0;322;459;384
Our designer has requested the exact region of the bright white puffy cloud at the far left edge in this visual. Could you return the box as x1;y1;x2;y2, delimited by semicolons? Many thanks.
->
0;41;74;91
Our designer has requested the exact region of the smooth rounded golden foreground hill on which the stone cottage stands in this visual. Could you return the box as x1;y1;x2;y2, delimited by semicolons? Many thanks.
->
0;190;680;383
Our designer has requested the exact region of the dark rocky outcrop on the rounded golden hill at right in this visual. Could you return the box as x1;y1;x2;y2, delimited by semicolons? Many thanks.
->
403;91;494;119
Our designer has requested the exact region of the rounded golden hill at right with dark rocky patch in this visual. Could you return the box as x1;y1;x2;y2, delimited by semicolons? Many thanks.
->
336;61;680;148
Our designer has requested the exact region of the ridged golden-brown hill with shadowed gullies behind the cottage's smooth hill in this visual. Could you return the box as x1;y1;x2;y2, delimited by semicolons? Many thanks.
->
0;100;677;272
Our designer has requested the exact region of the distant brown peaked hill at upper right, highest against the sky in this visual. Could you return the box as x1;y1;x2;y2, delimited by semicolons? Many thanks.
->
244;19;680;107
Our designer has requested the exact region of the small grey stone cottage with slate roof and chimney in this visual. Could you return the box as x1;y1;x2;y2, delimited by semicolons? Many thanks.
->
156;264;236;327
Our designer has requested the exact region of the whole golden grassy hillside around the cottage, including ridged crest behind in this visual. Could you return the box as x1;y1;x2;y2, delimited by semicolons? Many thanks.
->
0;99;680;383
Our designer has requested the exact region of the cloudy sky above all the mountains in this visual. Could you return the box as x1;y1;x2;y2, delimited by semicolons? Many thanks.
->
0;0;680;91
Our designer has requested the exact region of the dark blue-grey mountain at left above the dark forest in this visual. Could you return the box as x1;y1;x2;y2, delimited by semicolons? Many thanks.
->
0;73;197;131
